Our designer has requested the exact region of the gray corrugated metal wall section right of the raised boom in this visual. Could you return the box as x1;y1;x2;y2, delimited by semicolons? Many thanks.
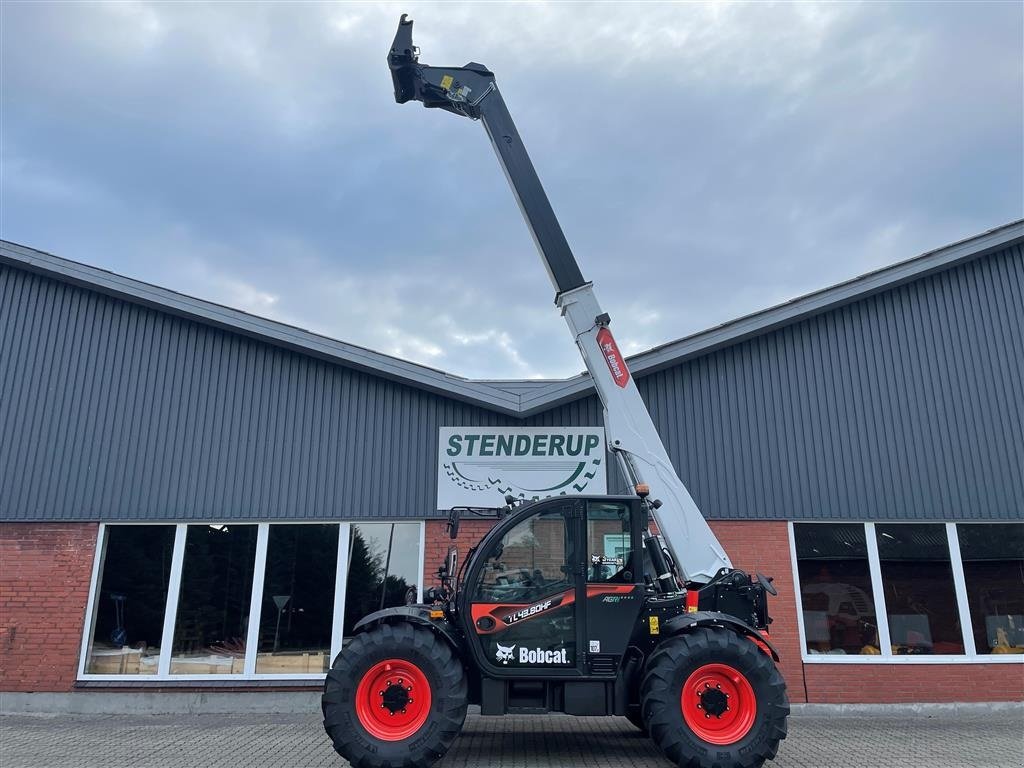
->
639;246;1024;519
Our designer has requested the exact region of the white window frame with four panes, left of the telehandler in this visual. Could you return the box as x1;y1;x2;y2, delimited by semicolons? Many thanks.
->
77;518;426;685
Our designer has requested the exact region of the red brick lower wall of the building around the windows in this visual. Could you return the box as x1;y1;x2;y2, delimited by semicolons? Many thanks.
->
0;519;1024;703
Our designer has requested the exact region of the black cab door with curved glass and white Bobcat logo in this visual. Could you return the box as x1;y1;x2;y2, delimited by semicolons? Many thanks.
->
466;500;585;677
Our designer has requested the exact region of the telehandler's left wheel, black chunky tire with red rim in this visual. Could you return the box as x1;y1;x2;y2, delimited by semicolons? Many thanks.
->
322;624;467;768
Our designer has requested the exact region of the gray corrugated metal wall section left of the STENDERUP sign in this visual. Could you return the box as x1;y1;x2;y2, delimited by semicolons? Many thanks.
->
0;267;520;519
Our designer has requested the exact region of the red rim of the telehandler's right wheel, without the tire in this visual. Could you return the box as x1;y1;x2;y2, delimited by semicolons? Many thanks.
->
680;664;758;744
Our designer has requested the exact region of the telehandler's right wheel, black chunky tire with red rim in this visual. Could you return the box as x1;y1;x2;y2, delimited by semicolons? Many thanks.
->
640;628;790;768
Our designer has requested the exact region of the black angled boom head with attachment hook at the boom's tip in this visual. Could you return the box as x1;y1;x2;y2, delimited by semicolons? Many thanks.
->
387;13;495;120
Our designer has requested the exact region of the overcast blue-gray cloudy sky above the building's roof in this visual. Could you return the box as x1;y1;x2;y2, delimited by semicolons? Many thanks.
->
0;1;1024;378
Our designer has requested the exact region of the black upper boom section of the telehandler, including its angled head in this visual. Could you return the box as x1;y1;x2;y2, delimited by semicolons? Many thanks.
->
387;14;586;293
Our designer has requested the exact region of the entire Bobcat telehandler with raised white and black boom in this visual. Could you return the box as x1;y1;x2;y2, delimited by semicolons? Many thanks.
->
323;15;790;768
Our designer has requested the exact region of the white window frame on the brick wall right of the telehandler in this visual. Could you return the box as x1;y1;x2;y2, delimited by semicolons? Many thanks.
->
786;520;1024;665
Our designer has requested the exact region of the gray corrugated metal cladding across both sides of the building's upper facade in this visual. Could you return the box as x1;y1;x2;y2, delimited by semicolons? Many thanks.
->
0;247;1024;519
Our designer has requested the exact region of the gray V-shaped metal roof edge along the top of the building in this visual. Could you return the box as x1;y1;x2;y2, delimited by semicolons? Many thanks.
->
0;219;1024;418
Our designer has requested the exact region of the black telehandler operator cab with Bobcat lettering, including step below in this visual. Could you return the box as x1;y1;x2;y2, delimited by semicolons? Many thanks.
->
458;497;649;714
